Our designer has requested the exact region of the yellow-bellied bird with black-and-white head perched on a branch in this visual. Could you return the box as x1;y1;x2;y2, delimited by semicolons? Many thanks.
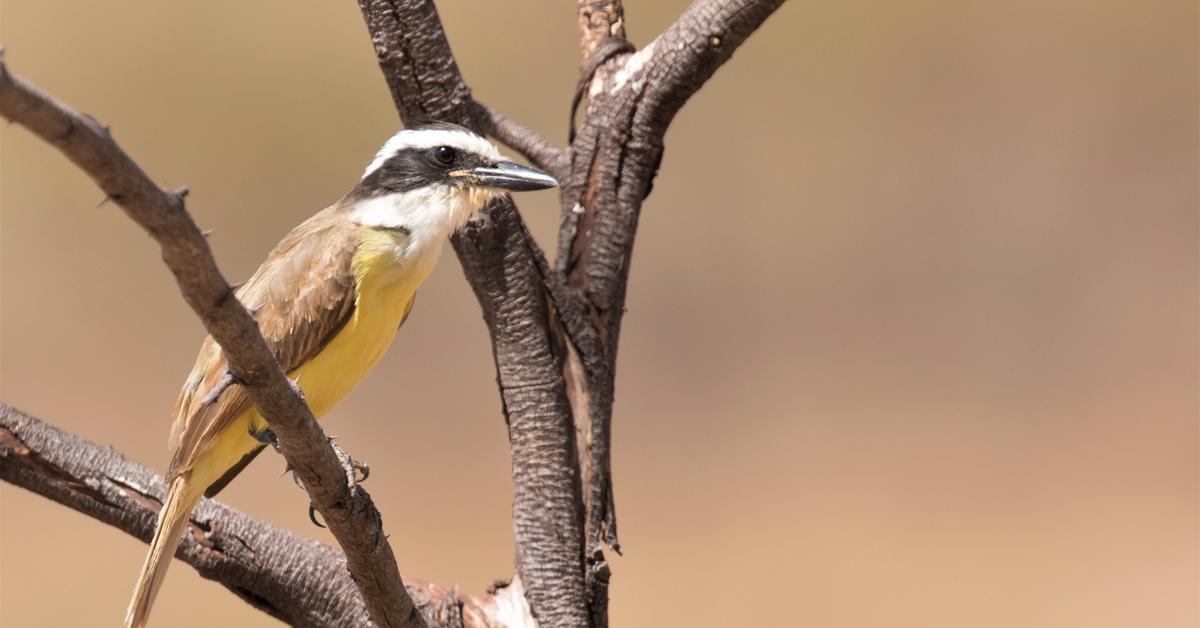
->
125;124;557;627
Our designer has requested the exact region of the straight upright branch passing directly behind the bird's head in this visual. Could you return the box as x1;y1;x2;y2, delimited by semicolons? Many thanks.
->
359;0;589;627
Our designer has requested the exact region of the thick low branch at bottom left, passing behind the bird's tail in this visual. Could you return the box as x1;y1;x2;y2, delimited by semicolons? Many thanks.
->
0;403;491;627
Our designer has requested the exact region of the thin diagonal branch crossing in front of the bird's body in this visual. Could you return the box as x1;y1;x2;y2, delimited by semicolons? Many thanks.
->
0;62;425;627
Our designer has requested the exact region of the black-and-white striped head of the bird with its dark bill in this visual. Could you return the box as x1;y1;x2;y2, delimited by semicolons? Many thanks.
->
349;122;558;235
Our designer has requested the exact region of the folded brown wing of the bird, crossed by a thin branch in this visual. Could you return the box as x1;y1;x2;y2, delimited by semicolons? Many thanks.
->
168;207;360;477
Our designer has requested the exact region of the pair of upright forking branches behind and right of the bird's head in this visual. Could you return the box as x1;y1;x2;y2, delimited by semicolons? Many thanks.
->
359;0;781;626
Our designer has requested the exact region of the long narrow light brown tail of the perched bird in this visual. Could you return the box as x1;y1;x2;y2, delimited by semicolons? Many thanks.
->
125;473;200;628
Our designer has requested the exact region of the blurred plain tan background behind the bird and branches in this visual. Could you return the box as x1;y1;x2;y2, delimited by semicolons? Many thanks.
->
0;0;1200;628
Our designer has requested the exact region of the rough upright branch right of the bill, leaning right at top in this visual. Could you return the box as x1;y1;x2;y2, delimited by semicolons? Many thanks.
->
556;0;782;626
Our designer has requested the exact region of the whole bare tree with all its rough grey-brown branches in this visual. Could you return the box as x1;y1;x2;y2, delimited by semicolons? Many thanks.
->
0;0;782;627
